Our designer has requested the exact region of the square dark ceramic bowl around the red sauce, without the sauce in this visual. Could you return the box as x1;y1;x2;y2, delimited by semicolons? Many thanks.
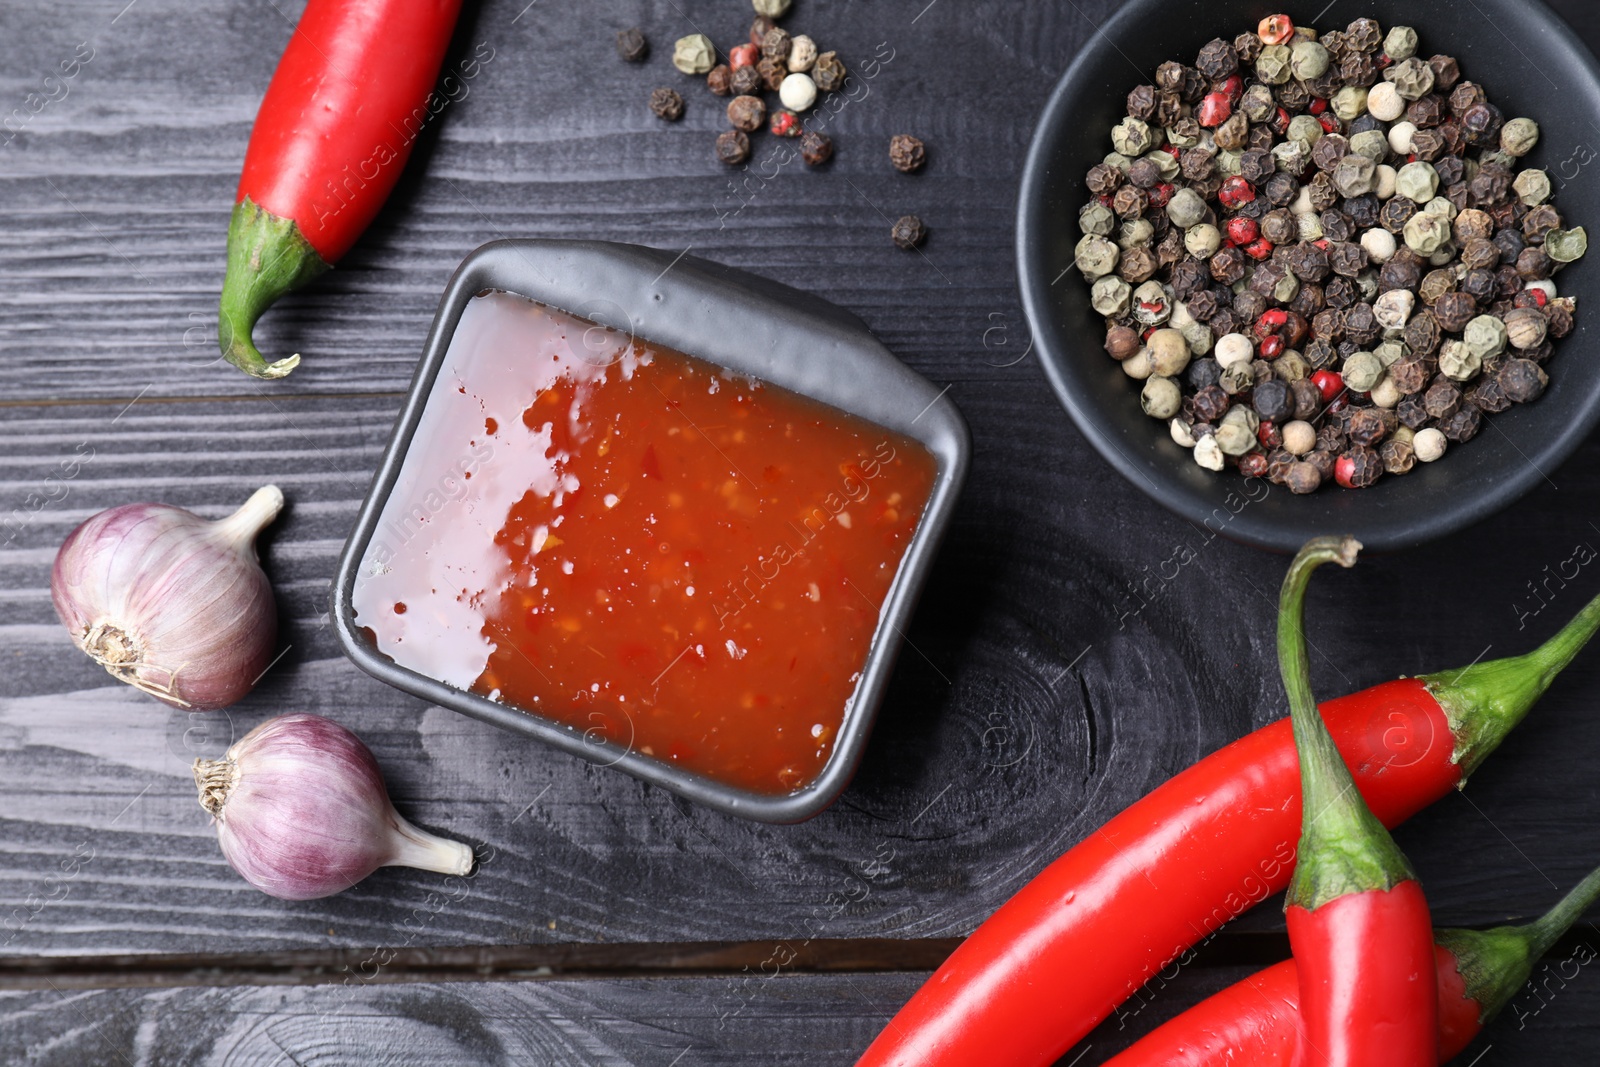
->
333;240;971;822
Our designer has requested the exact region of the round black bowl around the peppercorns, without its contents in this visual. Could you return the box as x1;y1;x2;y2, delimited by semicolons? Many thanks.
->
1016;0;1600;550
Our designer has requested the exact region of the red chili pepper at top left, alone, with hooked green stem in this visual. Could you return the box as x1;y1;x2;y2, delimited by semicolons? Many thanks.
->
216;0;461;378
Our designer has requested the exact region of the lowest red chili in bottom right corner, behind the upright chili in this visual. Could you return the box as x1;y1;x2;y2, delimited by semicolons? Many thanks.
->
1104;870;1600;1067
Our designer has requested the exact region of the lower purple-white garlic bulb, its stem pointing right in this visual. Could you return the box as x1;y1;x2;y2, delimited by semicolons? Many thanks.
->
194;715;472;901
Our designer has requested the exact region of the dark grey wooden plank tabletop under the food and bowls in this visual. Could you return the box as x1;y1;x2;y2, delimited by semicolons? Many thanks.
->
0;0;1600;1067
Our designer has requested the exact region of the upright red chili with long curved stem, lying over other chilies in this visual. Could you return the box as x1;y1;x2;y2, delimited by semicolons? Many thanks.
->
1278;537;1438;1067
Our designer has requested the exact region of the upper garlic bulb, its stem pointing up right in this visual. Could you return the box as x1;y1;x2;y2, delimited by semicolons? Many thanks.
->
50;485;283;712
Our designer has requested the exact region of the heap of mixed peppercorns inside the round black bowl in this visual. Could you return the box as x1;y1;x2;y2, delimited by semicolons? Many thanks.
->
1075;14;1587;493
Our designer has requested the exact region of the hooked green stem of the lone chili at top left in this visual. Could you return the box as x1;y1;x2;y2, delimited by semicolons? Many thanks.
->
216;197;328;379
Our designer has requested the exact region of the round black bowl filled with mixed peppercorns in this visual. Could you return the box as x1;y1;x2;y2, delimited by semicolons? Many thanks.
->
1018;0;1600;550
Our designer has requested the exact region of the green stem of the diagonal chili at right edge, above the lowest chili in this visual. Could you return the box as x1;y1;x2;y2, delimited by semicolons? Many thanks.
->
1422;597;1600;785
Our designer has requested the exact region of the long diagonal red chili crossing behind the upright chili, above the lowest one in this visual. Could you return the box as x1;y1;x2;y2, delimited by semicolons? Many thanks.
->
859;598;1600;1067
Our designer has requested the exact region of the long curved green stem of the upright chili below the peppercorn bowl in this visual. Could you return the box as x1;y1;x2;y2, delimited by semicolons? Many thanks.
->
1278;536;1416;912
